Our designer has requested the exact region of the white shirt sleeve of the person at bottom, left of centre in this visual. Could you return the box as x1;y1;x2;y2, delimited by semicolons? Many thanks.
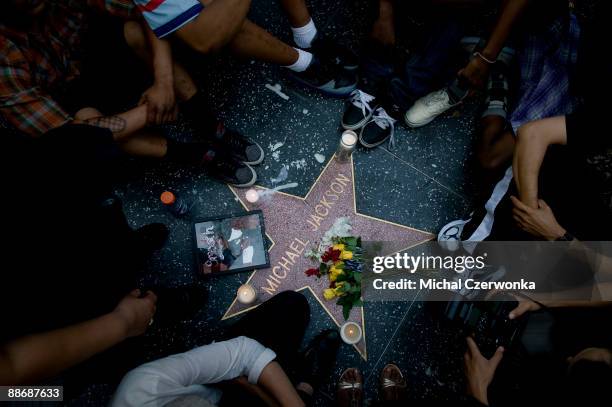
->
111;336;276;407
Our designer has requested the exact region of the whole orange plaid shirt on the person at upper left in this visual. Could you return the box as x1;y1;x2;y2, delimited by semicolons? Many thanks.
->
0;0;134;136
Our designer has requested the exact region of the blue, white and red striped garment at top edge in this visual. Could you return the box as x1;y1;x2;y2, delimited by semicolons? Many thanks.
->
134;0;204;38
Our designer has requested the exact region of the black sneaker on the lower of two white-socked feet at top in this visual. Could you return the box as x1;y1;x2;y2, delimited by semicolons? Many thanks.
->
291;56;357;98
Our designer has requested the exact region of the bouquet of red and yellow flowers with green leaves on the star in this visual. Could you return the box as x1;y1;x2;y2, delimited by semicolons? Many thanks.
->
306;230;363;320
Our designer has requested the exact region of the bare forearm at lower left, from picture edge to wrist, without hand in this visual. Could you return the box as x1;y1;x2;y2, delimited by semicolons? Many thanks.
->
0;312;126;385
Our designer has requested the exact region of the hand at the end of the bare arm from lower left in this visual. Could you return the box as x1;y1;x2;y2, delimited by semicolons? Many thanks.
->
113;289;157;338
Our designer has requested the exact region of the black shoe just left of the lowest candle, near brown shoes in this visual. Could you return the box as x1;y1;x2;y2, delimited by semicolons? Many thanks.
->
301;329;342;389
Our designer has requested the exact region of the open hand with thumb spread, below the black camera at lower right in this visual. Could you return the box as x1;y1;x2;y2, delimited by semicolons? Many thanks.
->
463;337;504;405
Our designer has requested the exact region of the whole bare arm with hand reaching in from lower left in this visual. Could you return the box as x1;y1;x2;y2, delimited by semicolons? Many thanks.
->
0;290;156;385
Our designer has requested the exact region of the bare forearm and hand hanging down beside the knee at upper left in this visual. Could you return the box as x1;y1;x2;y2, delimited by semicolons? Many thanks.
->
138;22;178;124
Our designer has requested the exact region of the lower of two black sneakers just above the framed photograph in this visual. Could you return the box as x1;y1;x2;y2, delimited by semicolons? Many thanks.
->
202;149;257;188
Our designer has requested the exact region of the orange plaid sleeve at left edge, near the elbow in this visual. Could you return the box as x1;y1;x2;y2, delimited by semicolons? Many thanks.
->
0;45;72;136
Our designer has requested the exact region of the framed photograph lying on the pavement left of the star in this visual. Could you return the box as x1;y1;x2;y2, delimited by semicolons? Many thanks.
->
193;211;270;277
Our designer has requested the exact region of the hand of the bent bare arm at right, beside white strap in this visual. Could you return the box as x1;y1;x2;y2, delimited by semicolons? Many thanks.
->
510;196;566;240
